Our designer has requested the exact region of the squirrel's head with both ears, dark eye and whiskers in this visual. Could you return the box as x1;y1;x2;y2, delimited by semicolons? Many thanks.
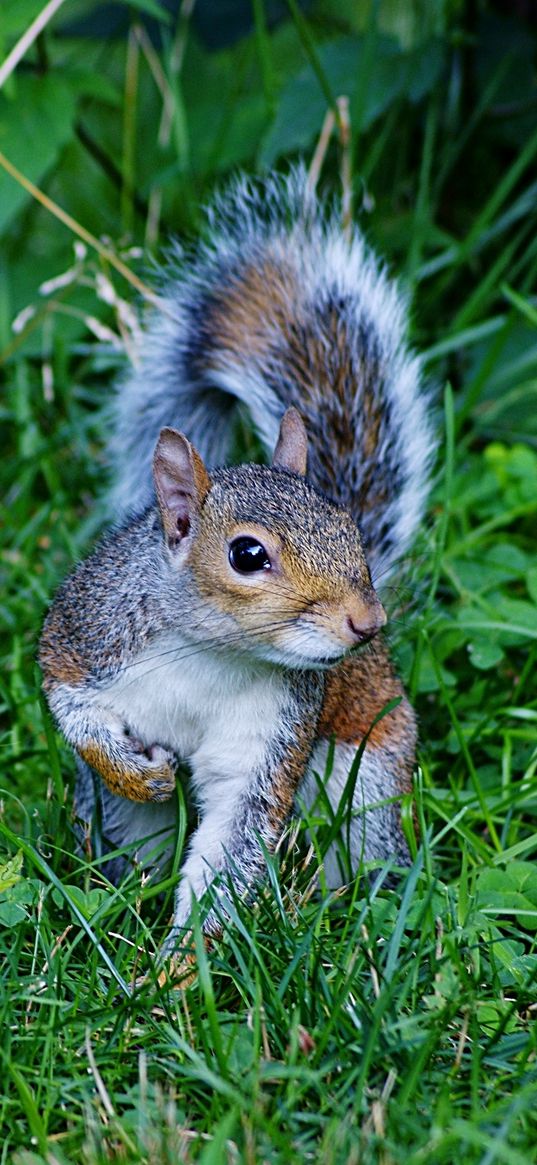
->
154;409;386;668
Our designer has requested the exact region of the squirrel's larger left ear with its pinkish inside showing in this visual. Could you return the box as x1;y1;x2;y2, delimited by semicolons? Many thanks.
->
153;429;211;545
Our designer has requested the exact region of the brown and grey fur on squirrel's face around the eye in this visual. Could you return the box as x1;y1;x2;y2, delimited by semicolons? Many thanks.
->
190;466;384;649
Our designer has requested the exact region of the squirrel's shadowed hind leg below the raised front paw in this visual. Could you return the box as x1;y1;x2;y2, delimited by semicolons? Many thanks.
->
75;757;177;885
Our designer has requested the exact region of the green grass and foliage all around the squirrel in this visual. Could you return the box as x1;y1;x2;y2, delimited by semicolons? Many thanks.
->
0;0;537;1165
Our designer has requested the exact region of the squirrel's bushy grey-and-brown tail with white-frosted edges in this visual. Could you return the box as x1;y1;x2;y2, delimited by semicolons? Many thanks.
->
111;167;434;578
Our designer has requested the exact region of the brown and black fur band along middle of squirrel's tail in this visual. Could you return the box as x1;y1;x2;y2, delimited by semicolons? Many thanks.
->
197;259;391;540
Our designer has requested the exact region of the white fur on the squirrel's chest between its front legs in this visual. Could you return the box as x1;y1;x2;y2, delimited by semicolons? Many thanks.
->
94;636;285;785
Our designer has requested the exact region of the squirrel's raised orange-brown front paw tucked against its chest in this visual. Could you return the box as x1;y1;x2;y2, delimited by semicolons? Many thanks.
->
78;733;175;802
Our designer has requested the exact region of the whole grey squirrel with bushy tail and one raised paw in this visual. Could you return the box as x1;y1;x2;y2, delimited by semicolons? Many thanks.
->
40;167;434;954
